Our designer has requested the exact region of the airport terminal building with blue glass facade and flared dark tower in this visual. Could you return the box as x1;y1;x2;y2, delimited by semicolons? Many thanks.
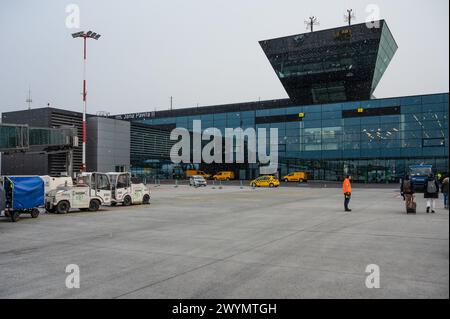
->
3;20;449;183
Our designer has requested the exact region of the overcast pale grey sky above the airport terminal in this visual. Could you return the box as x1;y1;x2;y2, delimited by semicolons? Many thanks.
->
0;0;449;114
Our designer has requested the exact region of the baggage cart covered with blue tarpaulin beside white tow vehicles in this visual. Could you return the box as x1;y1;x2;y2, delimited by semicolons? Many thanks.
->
1;176;45;222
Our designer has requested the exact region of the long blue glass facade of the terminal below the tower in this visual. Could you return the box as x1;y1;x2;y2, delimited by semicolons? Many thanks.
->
127;93;449;182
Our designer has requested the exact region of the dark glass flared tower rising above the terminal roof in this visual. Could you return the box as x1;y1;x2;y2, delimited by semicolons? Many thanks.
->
260;20;397;104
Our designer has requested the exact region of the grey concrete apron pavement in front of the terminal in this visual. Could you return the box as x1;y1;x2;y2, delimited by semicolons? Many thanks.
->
0;185;449;298
